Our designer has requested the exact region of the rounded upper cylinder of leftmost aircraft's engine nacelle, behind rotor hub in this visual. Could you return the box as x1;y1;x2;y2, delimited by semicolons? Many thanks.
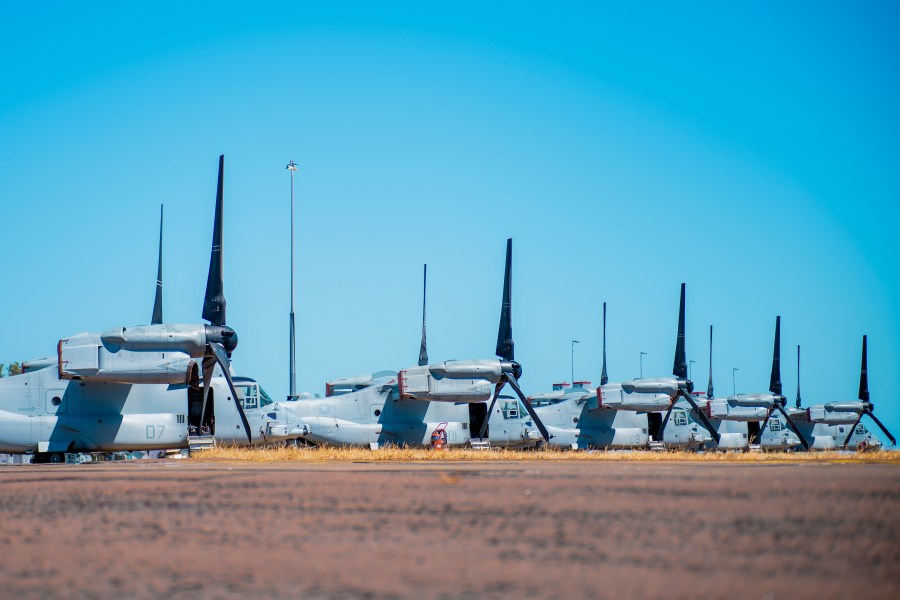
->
100;325;237;358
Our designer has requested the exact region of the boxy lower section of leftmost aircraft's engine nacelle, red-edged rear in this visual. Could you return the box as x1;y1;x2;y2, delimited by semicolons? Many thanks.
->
57;333;200;388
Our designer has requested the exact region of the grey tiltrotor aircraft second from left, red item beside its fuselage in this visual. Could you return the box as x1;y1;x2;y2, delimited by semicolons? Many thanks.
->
285;240;550;448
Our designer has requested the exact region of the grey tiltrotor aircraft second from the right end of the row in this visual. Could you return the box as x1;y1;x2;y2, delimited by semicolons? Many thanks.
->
706;316;808;450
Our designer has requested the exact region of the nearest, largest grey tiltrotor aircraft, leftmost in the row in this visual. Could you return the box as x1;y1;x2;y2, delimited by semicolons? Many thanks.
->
0;156;293;462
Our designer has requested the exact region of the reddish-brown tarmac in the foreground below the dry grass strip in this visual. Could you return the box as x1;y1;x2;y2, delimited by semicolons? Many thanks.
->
0;460;900;600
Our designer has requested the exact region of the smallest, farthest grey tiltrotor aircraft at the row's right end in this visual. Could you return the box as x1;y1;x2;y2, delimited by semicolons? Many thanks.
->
790;335;897;450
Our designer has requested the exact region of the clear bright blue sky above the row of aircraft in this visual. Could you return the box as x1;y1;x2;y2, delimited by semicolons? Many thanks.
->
0;2;900;434
